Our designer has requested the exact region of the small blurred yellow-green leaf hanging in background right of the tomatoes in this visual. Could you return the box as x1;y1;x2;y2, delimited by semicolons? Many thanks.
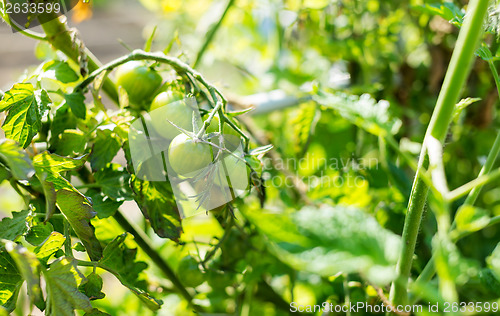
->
290;103;321;157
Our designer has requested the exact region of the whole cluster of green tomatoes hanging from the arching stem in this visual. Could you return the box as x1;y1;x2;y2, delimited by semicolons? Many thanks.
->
116;61;261;190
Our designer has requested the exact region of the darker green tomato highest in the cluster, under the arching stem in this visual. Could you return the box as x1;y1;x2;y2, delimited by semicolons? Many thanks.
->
116;61;163;110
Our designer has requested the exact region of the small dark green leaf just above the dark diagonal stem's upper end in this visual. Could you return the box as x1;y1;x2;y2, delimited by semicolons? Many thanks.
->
94;163;133;202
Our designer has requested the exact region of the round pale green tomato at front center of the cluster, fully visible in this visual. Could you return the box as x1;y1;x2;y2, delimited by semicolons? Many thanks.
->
168;134;212;178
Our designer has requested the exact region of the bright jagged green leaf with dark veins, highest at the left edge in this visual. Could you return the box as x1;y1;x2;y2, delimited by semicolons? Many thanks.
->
0;83;52;148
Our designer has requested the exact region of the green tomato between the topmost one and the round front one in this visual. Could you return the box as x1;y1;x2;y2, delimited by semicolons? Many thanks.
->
149;91;197;139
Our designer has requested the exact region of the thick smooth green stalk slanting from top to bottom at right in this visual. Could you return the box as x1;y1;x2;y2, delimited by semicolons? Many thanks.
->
390;0;489;305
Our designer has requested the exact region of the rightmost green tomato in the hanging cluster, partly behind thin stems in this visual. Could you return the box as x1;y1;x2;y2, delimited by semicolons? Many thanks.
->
214;151;249;190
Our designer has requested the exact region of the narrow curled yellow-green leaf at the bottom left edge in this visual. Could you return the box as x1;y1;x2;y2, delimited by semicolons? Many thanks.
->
3;241;45;310
